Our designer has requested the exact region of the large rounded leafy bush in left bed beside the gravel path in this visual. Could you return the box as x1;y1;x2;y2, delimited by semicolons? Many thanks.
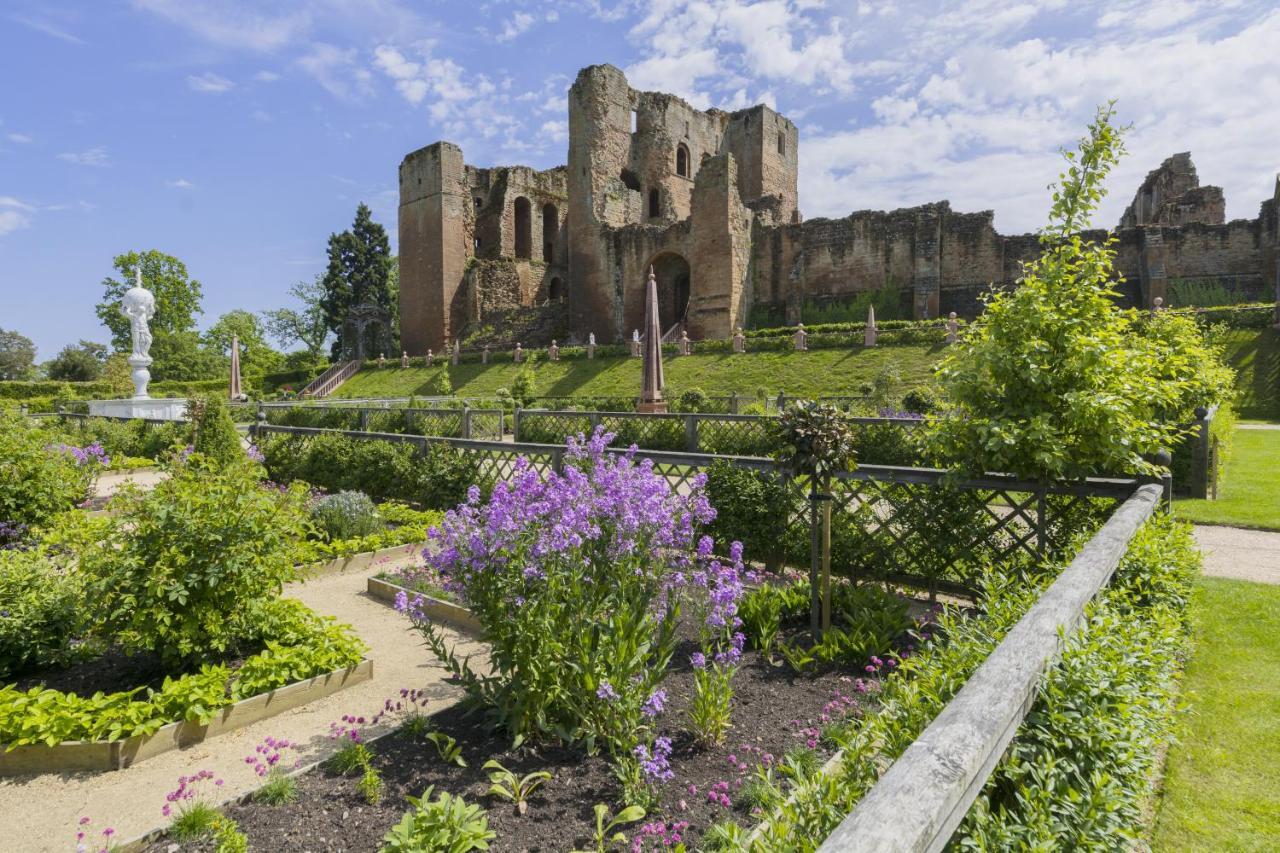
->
78;455;306;662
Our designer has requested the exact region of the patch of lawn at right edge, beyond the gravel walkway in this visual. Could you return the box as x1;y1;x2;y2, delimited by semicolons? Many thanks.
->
1174;429;1280;530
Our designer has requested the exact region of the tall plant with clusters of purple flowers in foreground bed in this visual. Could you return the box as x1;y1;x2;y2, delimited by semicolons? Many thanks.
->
402;429;716;794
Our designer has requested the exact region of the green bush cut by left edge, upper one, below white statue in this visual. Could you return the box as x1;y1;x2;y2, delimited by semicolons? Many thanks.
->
0;409;97;526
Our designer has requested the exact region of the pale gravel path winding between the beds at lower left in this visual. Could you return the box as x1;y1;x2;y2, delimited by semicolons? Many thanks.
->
0;555;480;853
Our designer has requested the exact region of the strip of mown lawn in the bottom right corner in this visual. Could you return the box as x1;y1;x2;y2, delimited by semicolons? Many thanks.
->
1152;578;1280;853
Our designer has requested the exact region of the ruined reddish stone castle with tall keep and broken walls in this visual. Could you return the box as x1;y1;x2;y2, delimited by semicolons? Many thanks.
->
399;65;1280;356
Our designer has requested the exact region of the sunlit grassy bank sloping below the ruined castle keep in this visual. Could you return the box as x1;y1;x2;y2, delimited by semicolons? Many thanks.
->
334;345;946;398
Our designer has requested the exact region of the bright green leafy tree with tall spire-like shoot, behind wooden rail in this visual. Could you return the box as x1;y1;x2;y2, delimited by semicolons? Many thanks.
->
929;105;1179;480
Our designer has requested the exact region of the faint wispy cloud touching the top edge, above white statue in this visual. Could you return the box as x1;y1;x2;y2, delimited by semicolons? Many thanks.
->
133;0;311;53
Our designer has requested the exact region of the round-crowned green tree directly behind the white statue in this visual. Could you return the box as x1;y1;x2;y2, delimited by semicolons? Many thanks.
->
97;248;204;350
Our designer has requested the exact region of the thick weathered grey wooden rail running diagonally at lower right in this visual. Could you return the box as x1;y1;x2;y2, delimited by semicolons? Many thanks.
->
819;484;1164;853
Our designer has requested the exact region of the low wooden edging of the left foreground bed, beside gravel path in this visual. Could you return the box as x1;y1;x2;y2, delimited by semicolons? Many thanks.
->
0;657;374;776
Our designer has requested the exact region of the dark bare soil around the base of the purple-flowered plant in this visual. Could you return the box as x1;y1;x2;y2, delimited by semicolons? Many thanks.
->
148;630;870;853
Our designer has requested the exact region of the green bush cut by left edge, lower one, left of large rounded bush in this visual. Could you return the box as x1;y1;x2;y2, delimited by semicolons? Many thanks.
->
0;548;86;679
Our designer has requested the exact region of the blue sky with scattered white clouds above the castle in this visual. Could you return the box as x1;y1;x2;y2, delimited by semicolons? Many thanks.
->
0;0;1280;360
